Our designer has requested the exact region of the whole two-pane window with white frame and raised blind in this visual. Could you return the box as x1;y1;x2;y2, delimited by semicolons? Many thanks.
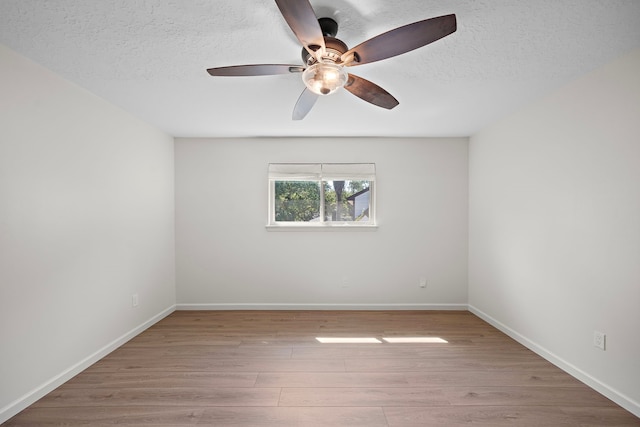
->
268;163;375;227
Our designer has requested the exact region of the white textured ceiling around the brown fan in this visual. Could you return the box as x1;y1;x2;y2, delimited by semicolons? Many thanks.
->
0;0;640;137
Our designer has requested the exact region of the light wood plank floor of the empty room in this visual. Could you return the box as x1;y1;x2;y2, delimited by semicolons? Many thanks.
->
6;311;640;427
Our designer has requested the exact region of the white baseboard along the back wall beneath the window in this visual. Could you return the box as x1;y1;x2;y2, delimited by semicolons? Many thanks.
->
176;303;468;311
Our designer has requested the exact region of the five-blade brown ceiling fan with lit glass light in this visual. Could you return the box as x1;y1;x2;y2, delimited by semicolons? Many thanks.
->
207;0;456;120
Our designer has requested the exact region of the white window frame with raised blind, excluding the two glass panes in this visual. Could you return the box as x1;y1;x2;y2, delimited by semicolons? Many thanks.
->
267;163;377;231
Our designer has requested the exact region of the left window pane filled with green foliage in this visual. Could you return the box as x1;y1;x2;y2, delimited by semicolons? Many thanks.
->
274;181;320;222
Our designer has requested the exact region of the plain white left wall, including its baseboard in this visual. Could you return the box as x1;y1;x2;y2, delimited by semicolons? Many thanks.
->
0;45;175;422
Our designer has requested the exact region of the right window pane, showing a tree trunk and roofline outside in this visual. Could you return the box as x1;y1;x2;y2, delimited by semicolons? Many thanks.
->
323;180;371;222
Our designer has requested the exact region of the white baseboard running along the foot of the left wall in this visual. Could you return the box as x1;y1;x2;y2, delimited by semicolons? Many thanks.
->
0;305;175;424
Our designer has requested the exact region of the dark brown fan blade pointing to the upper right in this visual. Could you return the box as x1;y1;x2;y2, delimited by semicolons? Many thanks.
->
342;14;457;66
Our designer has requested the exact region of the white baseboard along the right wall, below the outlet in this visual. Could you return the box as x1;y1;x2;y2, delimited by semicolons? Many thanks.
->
468;304;640;417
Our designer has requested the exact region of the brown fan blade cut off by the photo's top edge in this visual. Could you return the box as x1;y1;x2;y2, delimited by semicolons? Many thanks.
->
276;0;325;54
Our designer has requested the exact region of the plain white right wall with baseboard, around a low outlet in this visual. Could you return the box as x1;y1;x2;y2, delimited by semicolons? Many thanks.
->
469;51;640;416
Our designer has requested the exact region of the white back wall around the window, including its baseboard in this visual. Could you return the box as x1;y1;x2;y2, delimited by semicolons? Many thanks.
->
176;138;468;308
